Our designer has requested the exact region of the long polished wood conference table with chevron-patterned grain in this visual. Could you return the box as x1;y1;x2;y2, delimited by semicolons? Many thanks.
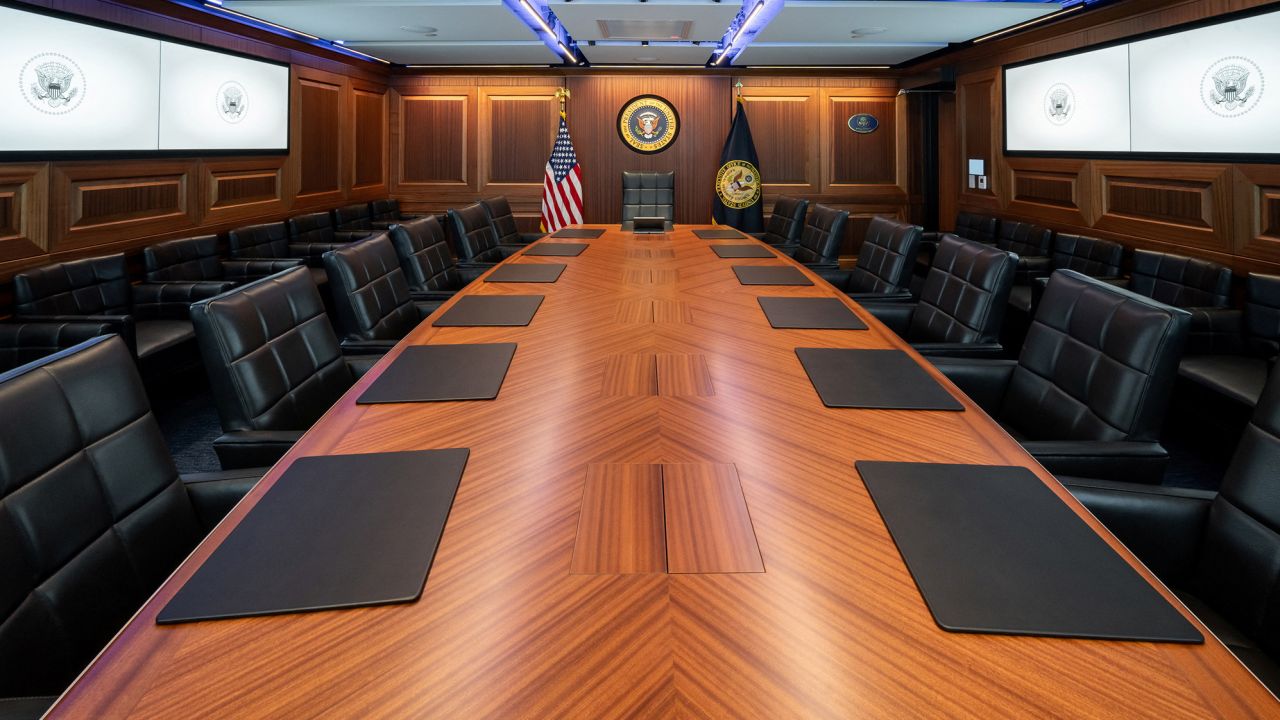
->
51;225;1280;719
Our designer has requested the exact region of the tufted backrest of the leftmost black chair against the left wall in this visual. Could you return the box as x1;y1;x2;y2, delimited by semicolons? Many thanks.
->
13;254;133;315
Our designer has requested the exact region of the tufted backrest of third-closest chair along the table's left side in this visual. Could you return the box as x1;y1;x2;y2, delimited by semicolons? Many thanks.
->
324;233;421;340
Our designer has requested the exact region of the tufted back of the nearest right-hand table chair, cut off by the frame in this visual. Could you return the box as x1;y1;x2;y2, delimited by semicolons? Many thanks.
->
1193;373;1280;656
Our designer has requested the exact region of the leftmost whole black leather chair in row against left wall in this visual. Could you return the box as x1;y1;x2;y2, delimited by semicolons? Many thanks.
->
13;254;202;360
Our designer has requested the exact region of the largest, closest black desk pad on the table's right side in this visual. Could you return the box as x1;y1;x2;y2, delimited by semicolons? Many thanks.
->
856;461;1204;643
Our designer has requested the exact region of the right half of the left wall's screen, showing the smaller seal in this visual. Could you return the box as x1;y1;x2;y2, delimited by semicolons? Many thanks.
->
160;42;289;150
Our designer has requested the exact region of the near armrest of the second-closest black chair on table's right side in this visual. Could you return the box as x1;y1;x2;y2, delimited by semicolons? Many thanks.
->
1023;439;1169;484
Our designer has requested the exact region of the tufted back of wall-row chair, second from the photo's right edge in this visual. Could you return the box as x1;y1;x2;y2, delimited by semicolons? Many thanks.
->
1129;250;1231;307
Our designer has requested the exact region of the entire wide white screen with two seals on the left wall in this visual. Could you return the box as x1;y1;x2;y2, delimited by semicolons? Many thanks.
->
0;6;289;152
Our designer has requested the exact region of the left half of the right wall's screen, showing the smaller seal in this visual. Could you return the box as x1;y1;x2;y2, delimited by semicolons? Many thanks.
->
1005;45;1129;152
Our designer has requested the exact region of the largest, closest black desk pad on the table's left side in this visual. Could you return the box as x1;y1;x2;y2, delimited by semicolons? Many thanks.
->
156;448;470;624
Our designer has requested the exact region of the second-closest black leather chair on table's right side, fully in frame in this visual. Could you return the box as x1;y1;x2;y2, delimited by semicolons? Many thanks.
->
934;270;1190;482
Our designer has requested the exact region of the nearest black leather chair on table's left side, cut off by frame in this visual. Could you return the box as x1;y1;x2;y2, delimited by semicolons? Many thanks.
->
0;336;262;717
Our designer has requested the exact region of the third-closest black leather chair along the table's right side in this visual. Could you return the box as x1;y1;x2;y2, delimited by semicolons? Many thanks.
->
864;234;1018;356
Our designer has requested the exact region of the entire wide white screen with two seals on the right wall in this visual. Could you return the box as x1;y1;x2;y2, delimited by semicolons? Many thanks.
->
1004;12;1280;159
